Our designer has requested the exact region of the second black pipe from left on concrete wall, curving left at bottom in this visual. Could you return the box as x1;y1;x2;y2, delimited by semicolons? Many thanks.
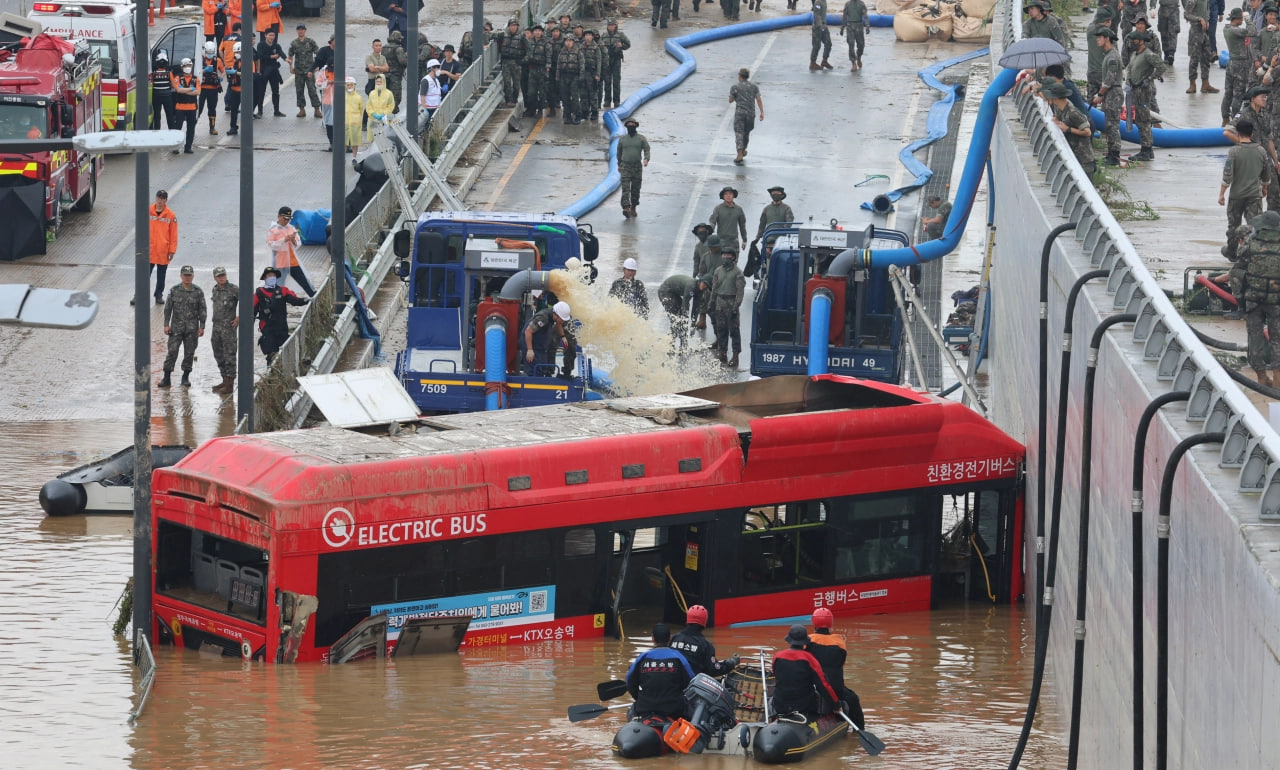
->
1009;263;1108;770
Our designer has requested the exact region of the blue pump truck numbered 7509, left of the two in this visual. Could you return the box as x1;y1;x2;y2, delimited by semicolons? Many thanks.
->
394;211;600;414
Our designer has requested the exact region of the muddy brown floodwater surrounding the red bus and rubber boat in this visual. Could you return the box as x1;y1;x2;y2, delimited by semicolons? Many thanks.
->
0;421;1065;770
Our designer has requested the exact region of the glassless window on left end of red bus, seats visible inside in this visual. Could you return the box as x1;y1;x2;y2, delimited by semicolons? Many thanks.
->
156;521;268;625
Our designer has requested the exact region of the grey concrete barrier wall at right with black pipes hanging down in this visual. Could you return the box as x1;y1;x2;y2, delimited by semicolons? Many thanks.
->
991;82;1280;767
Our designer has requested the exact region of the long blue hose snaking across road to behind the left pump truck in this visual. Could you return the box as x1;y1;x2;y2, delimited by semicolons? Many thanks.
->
559;13;893;219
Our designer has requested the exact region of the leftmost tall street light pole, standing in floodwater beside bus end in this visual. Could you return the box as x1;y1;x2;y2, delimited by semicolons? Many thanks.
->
133;3;151;647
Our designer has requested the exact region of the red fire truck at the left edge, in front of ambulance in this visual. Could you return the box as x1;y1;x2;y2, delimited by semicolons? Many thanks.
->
0;29;102;260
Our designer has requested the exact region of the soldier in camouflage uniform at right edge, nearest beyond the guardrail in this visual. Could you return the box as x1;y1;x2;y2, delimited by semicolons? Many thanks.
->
1240;211;1280;388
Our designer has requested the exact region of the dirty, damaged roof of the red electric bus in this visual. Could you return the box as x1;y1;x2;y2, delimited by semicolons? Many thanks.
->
152;375;1024;530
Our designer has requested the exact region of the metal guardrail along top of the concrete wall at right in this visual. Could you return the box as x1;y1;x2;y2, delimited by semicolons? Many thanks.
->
992;0;1280;519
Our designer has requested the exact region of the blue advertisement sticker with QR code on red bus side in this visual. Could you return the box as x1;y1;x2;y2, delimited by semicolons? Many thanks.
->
369;586;556;641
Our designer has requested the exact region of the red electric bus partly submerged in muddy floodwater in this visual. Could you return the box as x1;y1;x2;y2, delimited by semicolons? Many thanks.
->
152;375;1024;663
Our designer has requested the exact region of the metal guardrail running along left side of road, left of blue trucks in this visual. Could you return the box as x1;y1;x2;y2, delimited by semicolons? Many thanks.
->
249;0;579;432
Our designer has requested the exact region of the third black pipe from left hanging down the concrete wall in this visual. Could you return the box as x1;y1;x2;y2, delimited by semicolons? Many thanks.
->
1066;313;1138;770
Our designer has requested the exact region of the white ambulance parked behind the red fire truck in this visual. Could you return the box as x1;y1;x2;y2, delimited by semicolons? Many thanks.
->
27;0;137;130
